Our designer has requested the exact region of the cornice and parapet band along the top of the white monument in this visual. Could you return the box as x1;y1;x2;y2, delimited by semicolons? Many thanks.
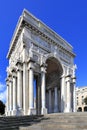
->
7;9;75;59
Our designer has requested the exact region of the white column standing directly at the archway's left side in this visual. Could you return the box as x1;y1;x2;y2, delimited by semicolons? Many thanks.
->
41;64;47;114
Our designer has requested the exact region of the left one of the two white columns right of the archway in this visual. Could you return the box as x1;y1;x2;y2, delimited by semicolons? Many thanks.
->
66;75;71;112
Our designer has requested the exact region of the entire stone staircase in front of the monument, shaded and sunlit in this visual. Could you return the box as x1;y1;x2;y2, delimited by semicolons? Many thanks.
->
0;112;87;130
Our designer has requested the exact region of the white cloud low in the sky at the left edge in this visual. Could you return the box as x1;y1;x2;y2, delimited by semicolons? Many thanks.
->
0;82;6;103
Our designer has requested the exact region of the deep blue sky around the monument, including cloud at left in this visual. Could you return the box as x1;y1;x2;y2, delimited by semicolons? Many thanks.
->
0;0;87;101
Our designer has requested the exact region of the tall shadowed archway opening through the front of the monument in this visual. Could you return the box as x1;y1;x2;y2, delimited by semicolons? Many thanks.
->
46;57;63;113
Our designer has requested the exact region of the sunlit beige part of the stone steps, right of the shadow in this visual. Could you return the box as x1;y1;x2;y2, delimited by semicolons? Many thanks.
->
20;113;87;130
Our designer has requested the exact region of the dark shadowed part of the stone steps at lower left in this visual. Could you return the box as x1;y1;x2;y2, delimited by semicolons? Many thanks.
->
0;115;43;130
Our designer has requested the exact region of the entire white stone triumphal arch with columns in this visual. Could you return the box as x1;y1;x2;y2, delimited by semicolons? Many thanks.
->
6;10;76;116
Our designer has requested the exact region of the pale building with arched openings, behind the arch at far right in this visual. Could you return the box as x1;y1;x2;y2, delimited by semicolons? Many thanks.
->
76;87;87;112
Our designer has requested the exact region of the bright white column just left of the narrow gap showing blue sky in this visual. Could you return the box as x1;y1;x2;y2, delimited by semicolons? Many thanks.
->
28;58;36;115
